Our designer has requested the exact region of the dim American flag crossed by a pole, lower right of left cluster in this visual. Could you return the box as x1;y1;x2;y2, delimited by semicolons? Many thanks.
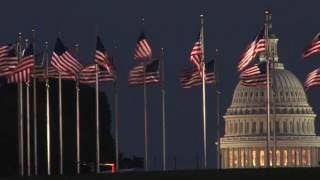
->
79;64;114;84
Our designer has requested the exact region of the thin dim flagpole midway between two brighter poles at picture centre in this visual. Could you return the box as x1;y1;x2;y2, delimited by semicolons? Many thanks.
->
161;48;167;171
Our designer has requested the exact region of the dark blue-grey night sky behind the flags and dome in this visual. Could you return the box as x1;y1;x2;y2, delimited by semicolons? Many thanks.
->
0;0;320;169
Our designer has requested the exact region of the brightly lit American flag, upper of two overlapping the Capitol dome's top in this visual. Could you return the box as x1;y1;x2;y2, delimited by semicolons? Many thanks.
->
238;28;266;73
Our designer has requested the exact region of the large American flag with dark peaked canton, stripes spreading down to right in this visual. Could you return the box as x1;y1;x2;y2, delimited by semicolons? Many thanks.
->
51;38;83;74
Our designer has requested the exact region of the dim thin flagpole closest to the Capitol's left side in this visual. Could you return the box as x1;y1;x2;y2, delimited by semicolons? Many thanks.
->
214;49;221;169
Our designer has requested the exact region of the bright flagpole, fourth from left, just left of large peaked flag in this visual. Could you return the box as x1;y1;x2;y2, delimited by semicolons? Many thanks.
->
45;42;51;175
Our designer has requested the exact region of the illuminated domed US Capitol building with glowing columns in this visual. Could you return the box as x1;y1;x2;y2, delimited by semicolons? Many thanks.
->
220;29;320;168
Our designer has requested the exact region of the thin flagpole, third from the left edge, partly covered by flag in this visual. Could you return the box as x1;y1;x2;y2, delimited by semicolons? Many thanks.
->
32;29;38;176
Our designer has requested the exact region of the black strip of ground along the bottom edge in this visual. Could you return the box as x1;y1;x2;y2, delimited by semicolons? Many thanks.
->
0;168;320;180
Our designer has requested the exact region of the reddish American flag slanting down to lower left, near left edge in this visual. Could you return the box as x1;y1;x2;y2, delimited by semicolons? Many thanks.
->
7;44;34;83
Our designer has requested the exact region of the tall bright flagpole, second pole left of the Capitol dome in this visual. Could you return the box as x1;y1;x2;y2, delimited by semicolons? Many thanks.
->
200;14;207;168
